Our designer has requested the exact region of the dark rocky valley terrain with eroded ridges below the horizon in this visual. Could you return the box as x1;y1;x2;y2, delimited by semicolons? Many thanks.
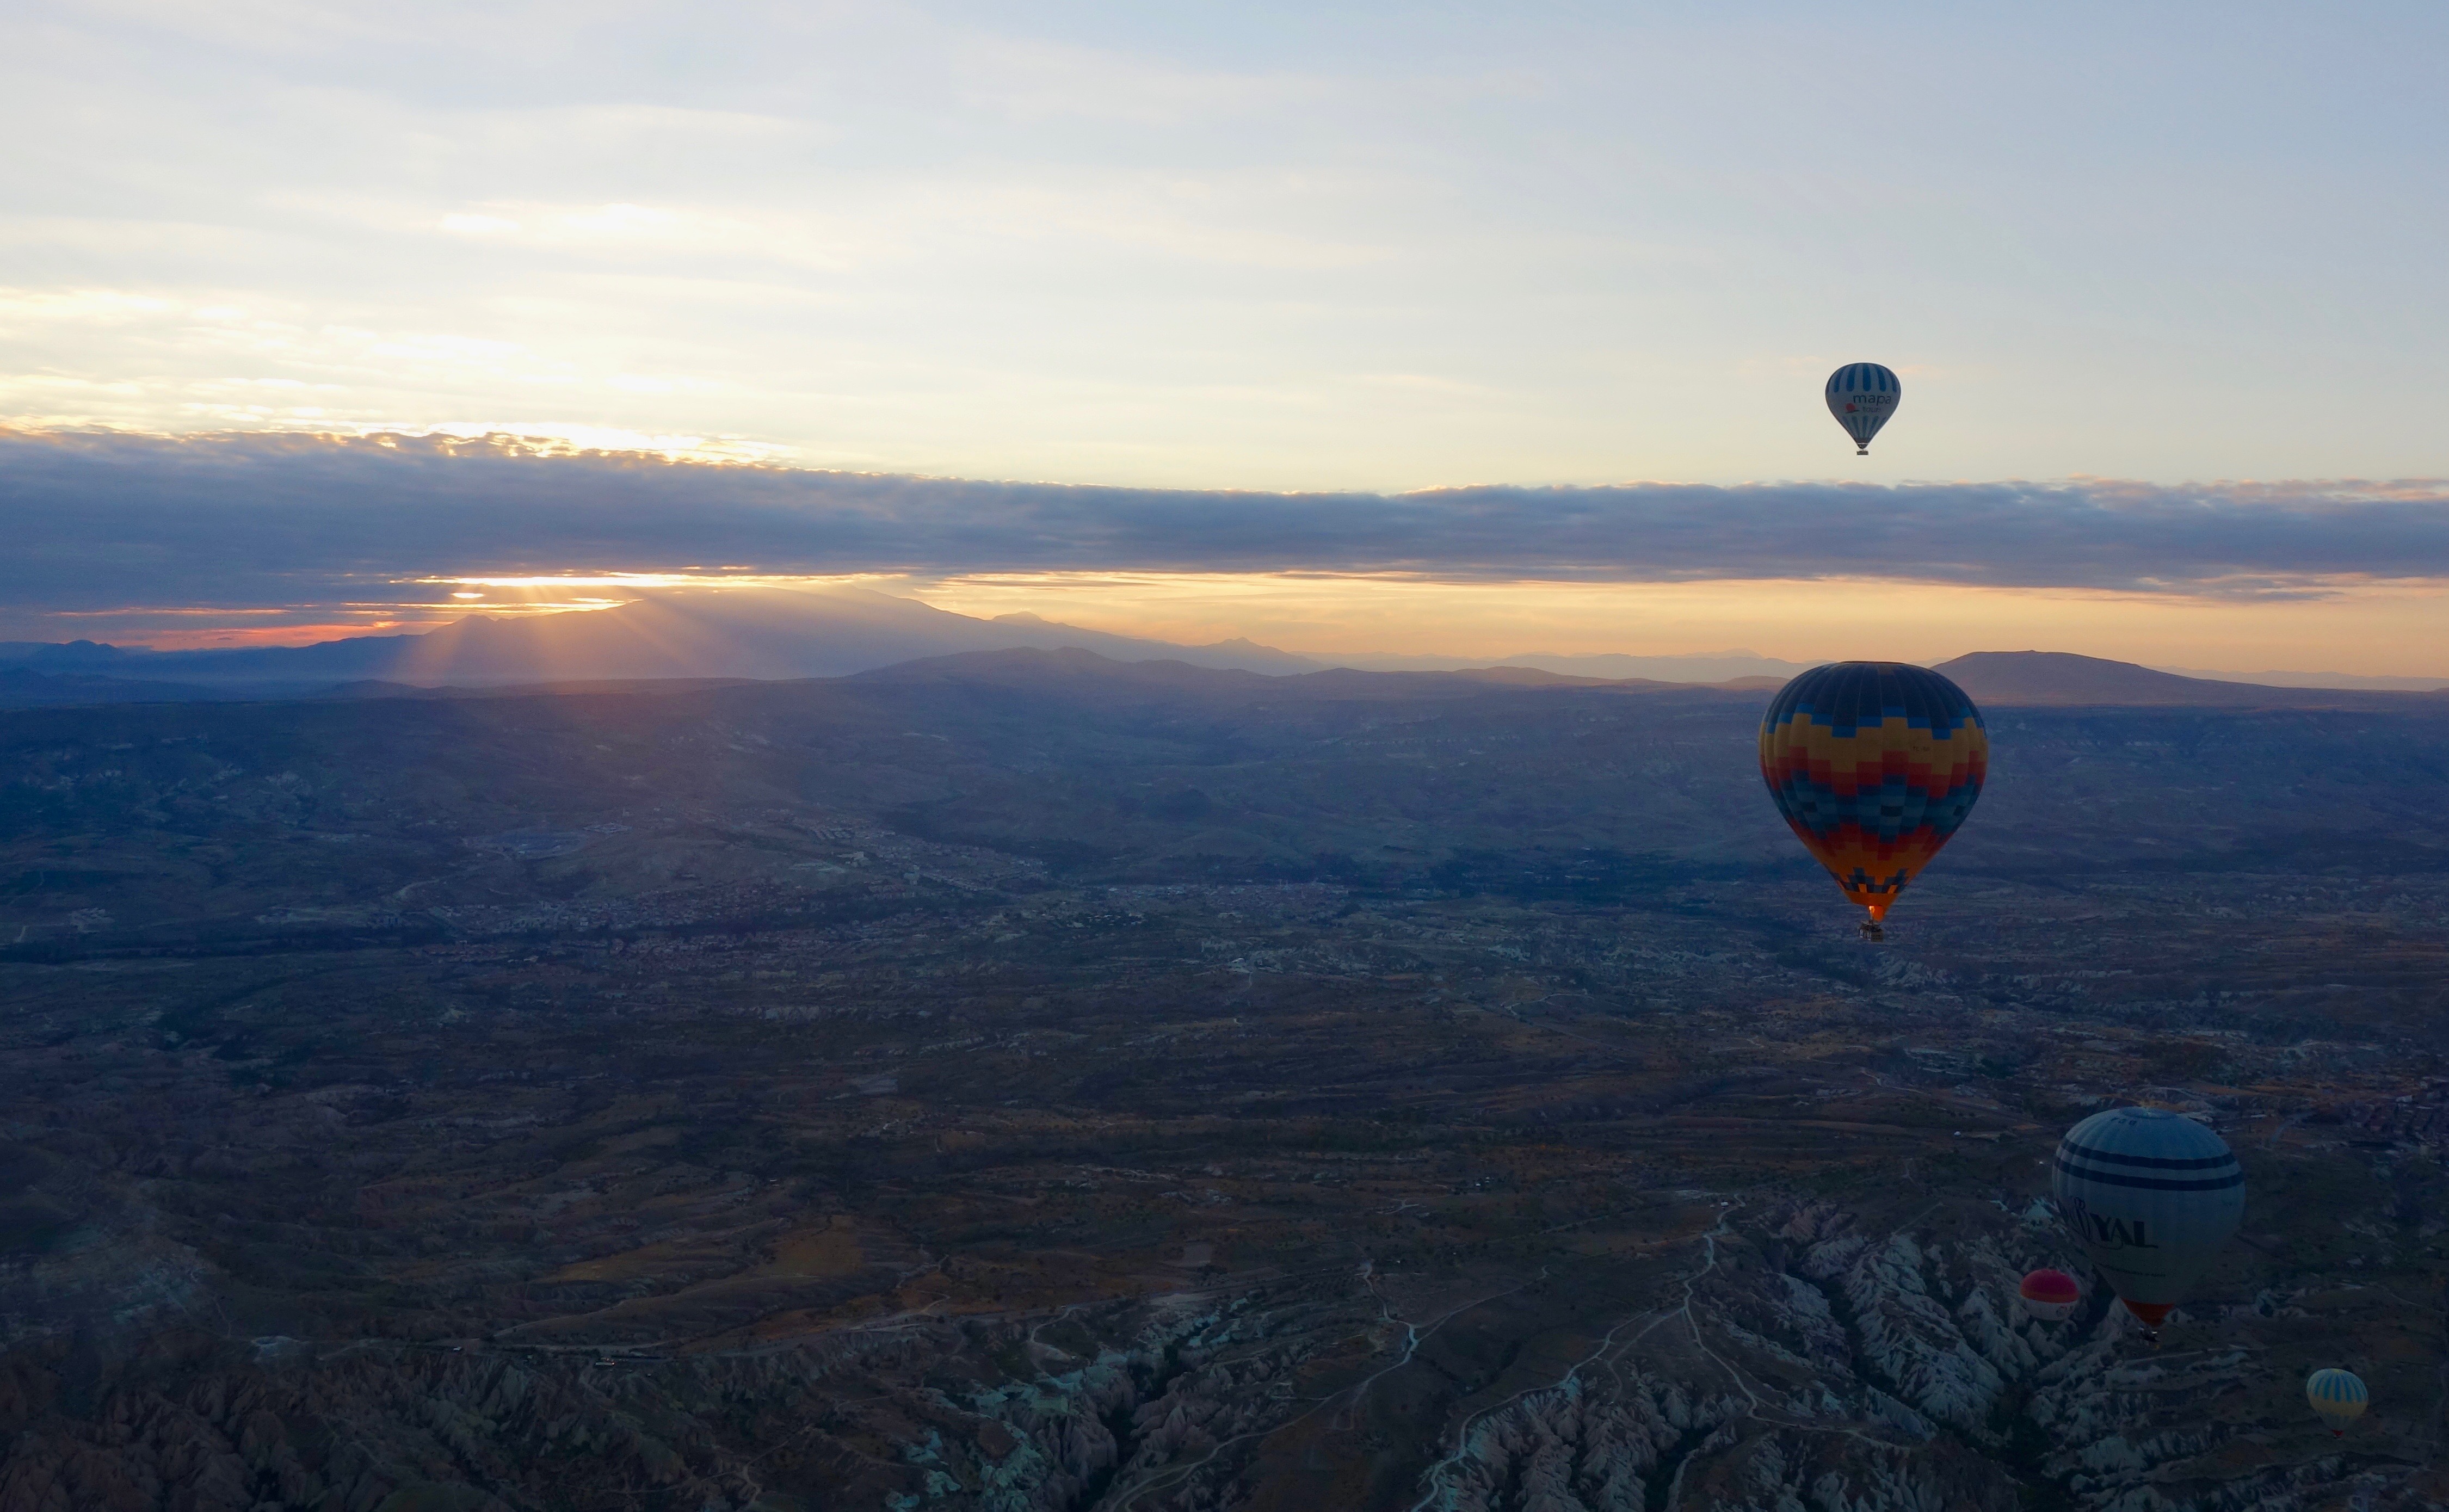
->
0;652;2449;1512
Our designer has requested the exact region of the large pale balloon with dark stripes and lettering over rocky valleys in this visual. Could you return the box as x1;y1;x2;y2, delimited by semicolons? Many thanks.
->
2050;1108;2246;1343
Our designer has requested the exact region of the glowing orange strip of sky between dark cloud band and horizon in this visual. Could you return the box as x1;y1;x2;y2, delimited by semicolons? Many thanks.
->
19;569;2449;676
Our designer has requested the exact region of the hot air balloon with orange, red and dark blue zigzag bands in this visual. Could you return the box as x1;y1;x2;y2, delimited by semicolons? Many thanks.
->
1761;662;1989;939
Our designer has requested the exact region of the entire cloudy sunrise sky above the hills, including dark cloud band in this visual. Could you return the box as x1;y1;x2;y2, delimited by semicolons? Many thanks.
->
0;0;2449;674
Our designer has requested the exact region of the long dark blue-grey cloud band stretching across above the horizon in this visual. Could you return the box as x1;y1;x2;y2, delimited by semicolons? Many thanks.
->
0;431;2449;615
